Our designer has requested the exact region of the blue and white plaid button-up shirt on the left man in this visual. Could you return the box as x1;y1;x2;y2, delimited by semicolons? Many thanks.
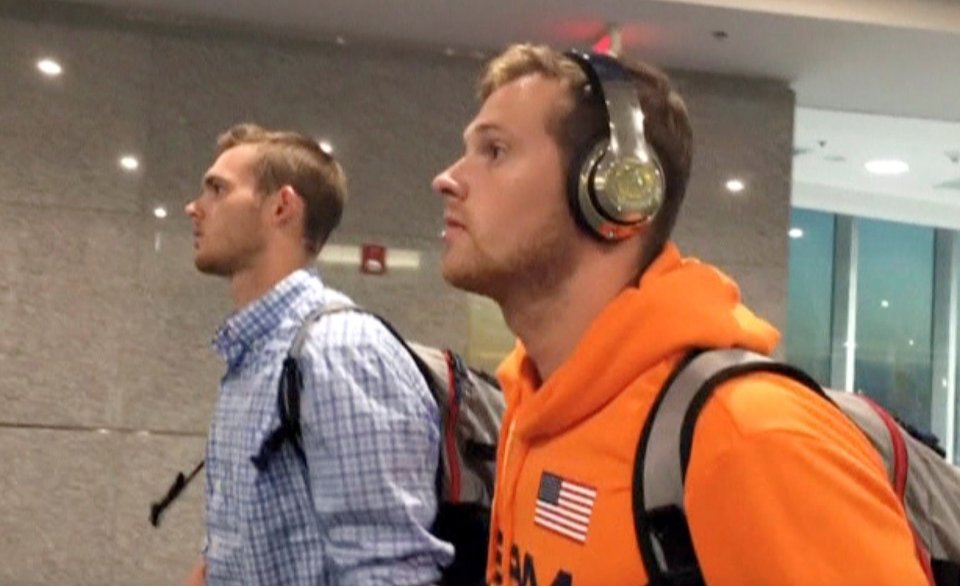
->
205;270;453;586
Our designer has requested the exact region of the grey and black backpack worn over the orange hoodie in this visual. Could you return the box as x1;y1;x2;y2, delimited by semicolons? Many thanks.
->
633;349;960;586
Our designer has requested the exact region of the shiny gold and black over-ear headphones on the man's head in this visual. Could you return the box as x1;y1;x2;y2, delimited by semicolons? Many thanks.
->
564;51;665;240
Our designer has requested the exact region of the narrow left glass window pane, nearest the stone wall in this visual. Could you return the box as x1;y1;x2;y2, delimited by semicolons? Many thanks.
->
785;208;834;385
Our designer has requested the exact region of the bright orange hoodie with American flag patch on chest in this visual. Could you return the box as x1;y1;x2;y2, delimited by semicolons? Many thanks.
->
487;245;925;586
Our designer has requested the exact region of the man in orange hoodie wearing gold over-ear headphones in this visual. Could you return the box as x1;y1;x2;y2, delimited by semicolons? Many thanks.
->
433;45;925;586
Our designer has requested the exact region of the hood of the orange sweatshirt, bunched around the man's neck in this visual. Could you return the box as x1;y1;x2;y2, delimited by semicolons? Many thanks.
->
497;244;780;443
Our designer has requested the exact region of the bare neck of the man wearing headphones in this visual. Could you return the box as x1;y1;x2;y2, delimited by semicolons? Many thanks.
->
500;252;636;386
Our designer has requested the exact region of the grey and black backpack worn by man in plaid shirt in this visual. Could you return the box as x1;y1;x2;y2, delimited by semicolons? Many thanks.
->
150;304;504;586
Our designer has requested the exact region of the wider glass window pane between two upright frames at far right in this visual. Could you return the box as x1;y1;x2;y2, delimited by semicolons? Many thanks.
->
854;219;934;430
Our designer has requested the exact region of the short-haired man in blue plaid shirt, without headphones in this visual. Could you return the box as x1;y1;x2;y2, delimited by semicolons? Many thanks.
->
185;125;453;586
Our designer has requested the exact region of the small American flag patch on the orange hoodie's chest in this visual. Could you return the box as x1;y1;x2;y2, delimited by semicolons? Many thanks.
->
533;472;597;543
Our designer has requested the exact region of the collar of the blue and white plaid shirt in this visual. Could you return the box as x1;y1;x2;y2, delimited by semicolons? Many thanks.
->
213;269;323;367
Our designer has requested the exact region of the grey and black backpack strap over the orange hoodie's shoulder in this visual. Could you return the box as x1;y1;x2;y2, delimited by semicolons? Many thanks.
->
633;349;825;586
